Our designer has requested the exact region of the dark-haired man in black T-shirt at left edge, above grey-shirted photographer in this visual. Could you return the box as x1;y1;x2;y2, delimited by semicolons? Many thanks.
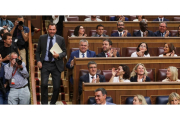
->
0;33;19;63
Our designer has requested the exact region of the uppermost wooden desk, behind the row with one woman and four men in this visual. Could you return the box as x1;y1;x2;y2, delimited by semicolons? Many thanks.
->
63;21;180;46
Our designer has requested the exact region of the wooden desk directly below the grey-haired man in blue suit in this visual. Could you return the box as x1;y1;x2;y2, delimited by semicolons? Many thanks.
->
72;57;180;104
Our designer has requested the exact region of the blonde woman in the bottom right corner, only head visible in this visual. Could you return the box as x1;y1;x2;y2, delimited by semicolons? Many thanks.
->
167;92;180;105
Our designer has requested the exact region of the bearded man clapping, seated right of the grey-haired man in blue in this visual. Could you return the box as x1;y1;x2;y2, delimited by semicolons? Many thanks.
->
96;39;120;57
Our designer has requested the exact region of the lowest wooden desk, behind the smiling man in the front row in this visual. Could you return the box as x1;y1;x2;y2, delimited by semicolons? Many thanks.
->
81;82;180;104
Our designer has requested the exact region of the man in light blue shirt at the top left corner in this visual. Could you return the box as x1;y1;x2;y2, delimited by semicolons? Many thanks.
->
0;15;14;31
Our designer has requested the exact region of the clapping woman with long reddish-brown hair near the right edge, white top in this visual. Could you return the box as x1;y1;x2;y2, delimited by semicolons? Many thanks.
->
159;43;177;57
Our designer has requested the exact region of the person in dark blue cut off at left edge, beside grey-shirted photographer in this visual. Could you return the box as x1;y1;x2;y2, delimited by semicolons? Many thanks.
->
0;54;9;104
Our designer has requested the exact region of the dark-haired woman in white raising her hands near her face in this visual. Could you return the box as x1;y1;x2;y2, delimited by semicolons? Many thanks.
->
109;65;130;82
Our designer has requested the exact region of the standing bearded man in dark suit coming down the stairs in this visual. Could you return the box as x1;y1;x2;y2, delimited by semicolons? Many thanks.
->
36;23;66;104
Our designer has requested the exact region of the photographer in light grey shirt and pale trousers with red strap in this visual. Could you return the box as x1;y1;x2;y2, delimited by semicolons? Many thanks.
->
4;52;30;105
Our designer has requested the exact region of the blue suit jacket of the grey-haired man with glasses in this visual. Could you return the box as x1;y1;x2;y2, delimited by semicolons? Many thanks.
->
66;50;96;69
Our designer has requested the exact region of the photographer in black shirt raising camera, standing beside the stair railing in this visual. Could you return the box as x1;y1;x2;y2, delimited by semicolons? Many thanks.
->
10;16;29;64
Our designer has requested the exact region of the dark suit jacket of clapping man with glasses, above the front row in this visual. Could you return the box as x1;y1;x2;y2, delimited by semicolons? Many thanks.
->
79;73;106;95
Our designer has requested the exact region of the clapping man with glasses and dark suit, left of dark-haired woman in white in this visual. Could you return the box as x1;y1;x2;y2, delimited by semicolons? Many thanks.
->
79;61;106;95
